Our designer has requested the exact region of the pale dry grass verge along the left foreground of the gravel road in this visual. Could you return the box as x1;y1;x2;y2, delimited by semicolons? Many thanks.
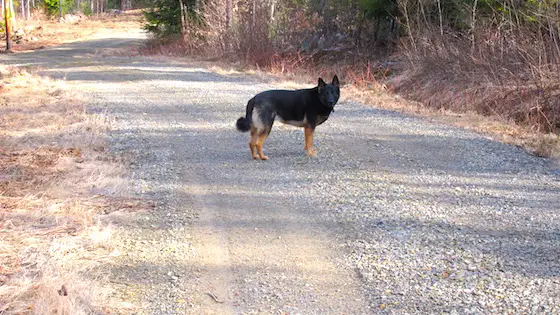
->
0;67;149;314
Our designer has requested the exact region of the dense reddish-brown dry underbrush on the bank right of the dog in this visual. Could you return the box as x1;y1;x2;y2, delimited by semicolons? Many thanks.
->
387;27;560;156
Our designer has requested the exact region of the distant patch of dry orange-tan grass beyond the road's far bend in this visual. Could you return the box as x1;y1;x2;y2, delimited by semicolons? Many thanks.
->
0;10;143;52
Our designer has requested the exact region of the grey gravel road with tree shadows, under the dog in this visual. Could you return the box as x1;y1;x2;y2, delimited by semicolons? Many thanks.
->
0;29;560;314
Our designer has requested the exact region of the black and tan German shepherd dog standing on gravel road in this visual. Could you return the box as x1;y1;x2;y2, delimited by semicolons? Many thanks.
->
237;75;340;160
